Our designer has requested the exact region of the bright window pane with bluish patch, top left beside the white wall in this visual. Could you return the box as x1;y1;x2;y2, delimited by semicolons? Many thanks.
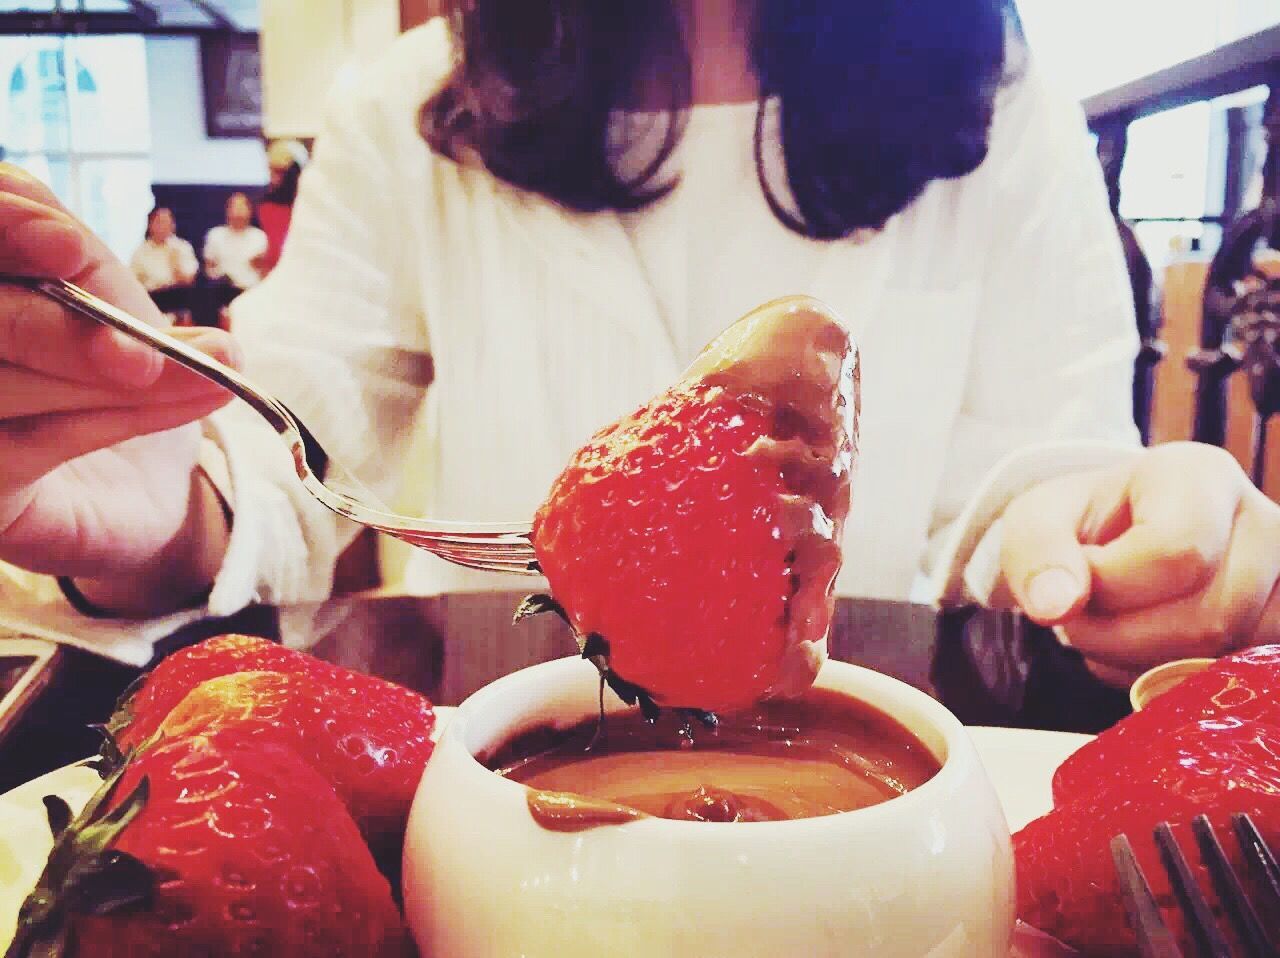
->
64;36;151;154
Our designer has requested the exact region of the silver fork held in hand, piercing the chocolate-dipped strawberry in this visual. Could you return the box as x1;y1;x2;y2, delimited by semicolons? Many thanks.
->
13;277;539;575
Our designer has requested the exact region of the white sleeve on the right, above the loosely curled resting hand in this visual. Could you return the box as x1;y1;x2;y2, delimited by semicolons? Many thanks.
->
928;64;1138;603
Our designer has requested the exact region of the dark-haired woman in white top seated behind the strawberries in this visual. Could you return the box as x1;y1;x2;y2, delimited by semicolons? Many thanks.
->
0;0;1280;670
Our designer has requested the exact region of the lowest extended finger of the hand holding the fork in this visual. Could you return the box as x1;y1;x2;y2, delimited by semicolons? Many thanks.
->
0;392;230;488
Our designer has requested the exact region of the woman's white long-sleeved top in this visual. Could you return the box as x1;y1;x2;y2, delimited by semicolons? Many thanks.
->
0;20;1137;662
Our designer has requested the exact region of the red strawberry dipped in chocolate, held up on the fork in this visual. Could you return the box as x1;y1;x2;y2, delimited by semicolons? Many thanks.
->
534;297;858;710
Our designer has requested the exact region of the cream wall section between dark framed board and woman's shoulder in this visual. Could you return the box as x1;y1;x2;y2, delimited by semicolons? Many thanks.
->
261;0;399;137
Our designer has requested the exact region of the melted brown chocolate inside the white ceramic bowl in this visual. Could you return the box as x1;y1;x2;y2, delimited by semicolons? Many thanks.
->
481;689;940;831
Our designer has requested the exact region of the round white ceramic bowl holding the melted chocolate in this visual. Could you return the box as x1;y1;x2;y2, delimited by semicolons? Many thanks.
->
404;658;1014;958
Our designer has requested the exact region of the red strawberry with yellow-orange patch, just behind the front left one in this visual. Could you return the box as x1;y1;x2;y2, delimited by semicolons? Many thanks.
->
159;671;434;856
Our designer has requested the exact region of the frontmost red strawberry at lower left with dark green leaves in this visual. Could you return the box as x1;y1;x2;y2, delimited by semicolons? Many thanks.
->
9;736;406;958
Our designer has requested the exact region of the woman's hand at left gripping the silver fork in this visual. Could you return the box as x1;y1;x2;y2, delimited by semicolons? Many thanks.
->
0;165;234;612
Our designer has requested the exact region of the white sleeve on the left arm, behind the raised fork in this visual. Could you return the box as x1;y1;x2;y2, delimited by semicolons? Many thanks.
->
210;28;449;622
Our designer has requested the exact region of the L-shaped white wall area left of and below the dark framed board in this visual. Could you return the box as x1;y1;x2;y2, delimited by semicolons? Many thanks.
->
147;37;266;186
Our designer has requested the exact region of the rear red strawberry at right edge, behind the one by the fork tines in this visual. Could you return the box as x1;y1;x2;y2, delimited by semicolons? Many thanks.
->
1053;645;1280;804
